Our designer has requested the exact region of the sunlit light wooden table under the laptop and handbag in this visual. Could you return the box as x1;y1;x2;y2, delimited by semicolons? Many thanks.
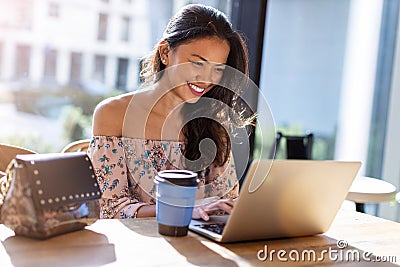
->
0;210;400;267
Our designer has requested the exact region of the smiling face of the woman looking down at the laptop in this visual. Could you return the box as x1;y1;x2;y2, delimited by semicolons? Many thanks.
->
162;37;230;102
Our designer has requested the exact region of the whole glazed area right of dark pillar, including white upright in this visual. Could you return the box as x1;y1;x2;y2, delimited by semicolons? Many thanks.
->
256;0;399;219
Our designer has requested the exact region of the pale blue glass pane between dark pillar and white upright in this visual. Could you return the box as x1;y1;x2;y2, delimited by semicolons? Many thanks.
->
256;0;349;159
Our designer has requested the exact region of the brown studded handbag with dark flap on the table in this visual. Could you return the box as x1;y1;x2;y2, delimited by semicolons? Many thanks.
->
0;152;101;239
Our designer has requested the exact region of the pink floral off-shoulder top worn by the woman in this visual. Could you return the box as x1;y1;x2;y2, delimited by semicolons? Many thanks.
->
88;136;239;218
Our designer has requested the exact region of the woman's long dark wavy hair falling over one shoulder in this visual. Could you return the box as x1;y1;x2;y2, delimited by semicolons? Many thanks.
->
141;4;252;171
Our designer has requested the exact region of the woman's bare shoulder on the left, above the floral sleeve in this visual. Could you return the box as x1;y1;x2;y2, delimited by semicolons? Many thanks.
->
93;93;133;136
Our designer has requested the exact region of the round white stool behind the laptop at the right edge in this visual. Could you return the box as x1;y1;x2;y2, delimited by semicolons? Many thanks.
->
346;176;396;215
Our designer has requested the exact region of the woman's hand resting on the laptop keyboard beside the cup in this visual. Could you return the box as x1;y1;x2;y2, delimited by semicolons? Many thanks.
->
192;198;236;221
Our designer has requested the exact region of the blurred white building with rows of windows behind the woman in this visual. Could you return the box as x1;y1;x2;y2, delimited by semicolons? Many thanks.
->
0;0;171;91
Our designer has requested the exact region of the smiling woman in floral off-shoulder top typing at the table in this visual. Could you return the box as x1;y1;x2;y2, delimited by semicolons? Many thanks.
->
88;5;255;220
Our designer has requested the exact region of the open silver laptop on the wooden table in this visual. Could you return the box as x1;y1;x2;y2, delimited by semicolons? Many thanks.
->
189;160;361;243
